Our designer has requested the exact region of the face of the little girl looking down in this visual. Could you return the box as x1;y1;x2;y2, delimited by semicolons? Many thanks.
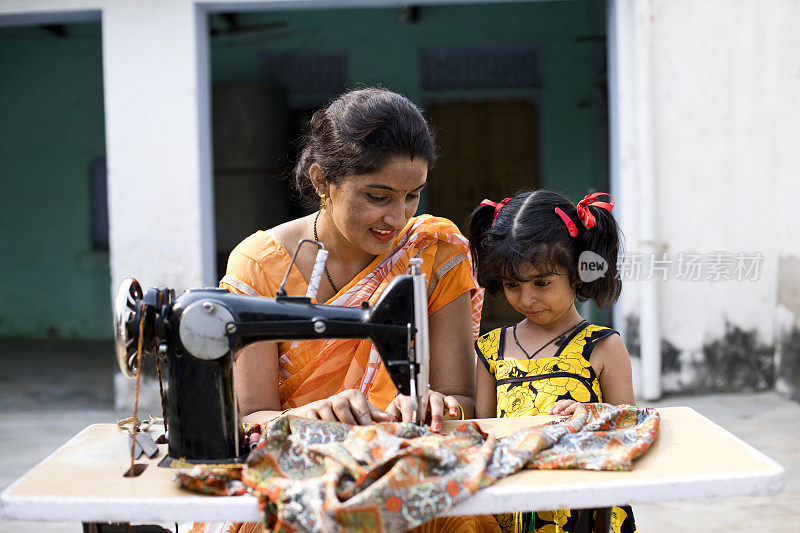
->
503;266;577;327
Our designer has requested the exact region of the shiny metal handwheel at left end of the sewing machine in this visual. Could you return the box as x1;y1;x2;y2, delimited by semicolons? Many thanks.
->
114;278;144;378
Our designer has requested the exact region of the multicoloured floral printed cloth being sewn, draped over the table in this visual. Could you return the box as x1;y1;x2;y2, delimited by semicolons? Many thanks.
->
177;403;660;532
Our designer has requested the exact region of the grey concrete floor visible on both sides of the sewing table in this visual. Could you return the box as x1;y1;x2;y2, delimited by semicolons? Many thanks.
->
0;341;800;533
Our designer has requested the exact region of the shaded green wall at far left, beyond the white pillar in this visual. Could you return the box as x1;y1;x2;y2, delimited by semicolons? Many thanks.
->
0;23;111;338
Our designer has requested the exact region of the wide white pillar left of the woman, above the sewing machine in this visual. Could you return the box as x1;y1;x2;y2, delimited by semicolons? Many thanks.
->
102;0;217;291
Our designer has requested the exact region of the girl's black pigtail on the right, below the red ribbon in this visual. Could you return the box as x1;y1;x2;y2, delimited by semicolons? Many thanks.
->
576;200;622;309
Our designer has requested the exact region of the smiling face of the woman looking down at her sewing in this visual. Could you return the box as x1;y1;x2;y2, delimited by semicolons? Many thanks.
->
322;157;428;255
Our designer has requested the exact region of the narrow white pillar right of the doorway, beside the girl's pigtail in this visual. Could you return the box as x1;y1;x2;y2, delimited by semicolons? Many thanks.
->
608;0;662;400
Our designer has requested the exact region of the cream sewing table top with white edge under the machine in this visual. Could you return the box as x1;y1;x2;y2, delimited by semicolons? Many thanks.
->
0;407;784;523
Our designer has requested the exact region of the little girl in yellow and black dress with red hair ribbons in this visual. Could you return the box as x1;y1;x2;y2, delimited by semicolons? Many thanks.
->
470;190;635;532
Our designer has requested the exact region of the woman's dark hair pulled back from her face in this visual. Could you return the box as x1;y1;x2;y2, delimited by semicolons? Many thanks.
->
294;88;436;200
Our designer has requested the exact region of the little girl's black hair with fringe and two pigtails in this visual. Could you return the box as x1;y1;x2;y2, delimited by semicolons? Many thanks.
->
469;190;622;308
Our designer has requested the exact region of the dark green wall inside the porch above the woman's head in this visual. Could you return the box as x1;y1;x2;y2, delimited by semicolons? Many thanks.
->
211;1;607;198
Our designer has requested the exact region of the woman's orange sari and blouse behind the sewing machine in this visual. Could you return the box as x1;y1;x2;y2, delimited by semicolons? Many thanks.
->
220;215;483;409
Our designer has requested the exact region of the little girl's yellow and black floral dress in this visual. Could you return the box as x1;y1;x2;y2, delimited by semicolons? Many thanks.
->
475;324;636;533
